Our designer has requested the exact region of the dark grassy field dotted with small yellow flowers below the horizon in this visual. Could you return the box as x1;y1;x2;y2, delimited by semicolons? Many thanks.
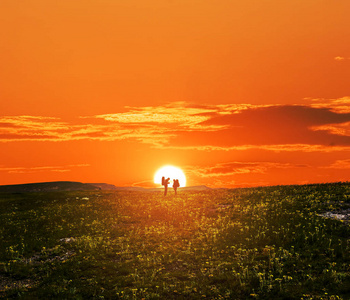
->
0;183;350;299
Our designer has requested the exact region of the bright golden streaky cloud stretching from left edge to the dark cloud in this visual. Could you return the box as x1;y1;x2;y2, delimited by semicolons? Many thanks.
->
0;102;270;146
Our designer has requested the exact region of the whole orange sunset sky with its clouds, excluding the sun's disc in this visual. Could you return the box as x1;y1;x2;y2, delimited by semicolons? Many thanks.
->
0;0;350;187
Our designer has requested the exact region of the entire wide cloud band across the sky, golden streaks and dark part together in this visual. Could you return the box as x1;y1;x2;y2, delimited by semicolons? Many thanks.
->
0;101;350;152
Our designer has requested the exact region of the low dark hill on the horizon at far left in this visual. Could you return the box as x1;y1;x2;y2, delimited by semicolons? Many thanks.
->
0;181;99;193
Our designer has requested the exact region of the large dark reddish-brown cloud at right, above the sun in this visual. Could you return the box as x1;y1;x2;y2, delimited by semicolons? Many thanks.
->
171;106;350;150
